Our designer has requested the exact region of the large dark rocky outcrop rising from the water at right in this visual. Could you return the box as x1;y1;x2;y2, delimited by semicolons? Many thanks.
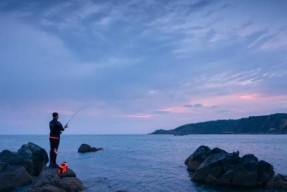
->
185;146;274;188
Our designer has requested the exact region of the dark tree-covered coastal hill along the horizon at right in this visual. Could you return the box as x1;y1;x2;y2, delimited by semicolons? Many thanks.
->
151;113;287;135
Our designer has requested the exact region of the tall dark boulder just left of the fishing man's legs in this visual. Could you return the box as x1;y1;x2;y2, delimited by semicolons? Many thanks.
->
17;142;49;176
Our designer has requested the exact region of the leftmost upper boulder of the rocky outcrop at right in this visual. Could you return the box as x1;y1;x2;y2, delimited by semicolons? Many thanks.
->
184;145;211;171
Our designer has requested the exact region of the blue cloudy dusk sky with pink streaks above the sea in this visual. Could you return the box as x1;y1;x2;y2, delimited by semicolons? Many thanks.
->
0;0;287;134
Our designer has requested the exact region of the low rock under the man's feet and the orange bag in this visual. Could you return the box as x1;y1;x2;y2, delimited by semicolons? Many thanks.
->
30;168;84;192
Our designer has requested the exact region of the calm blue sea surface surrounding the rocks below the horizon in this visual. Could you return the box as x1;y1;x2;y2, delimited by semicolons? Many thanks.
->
0;134;287;192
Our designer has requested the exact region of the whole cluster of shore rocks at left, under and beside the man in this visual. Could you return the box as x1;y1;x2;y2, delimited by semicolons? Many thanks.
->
0;142;84;192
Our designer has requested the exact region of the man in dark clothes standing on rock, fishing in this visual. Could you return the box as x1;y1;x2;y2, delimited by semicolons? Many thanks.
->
49;112;68;168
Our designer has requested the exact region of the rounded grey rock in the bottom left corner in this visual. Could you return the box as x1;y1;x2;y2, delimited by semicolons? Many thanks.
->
0;162;32;191
